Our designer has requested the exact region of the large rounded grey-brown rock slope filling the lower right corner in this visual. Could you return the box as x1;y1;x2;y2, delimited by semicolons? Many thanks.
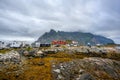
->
52;57;120;80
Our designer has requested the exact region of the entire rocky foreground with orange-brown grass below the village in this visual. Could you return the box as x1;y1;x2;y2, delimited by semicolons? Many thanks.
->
0;47;120;80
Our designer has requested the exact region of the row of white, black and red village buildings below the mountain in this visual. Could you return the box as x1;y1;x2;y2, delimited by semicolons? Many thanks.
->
0;40;107;49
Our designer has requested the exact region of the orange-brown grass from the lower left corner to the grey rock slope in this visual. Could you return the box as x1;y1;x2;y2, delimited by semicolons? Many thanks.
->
0;53;72;80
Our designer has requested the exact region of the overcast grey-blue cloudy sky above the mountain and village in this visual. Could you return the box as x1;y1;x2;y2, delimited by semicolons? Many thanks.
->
0;0;120;43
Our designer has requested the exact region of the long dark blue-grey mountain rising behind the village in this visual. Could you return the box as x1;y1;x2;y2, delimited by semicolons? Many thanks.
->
36;29;114;45
